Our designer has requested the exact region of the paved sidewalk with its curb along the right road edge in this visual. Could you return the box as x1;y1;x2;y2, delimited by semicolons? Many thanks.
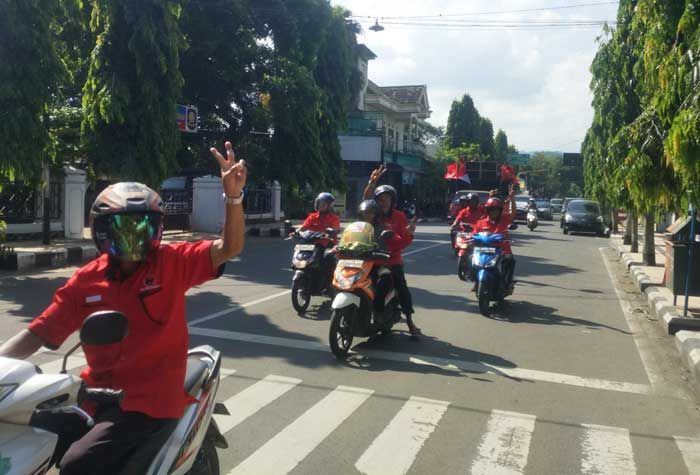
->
610;234;700;388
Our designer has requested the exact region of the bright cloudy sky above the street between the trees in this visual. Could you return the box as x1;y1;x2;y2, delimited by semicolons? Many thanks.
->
331;0;617;152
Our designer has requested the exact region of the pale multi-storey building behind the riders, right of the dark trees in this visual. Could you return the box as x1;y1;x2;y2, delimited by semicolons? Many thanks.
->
338;45;431;215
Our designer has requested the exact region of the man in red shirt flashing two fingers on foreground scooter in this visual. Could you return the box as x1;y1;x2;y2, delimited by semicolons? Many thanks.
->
0;142;246;475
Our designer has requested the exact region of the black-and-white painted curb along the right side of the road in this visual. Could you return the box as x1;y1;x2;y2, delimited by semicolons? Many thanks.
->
611;240;700;390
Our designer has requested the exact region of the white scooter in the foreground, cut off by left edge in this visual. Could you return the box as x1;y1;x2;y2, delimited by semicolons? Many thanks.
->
0;311;228;475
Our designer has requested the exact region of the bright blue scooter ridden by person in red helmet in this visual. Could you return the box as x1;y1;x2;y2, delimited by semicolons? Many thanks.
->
471;230;517;317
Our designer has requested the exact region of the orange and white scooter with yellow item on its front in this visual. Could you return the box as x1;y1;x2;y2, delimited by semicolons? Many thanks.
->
328;222;401;358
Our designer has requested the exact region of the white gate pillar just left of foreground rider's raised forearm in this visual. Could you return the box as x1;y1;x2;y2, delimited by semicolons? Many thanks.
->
190;175;224;233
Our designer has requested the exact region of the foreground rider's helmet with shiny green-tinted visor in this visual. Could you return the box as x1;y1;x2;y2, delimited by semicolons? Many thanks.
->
90;182;163;261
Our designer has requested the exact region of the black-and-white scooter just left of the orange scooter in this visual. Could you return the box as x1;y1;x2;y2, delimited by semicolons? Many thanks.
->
292;228;336;315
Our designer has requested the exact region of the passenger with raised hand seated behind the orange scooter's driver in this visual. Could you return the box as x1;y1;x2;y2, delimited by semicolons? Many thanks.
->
364;165;421;339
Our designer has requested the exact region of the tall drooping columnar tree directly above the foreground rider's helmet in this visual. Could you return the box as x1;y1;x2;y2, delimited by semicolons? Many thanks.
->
82;0;183;186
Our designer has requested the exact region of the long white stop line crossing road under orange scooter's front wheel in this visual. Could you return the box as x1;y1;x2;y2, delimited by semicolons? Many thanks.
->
190;327;652;395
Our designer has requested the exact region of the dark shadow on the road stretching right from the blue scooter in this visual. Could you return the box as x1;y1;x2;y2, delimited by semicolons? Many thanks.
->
489;300;631;335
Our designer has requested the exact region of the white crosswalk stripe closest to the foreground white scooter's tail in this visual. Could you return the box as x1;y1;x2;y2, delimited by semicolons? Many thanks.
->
214;375;301;434
